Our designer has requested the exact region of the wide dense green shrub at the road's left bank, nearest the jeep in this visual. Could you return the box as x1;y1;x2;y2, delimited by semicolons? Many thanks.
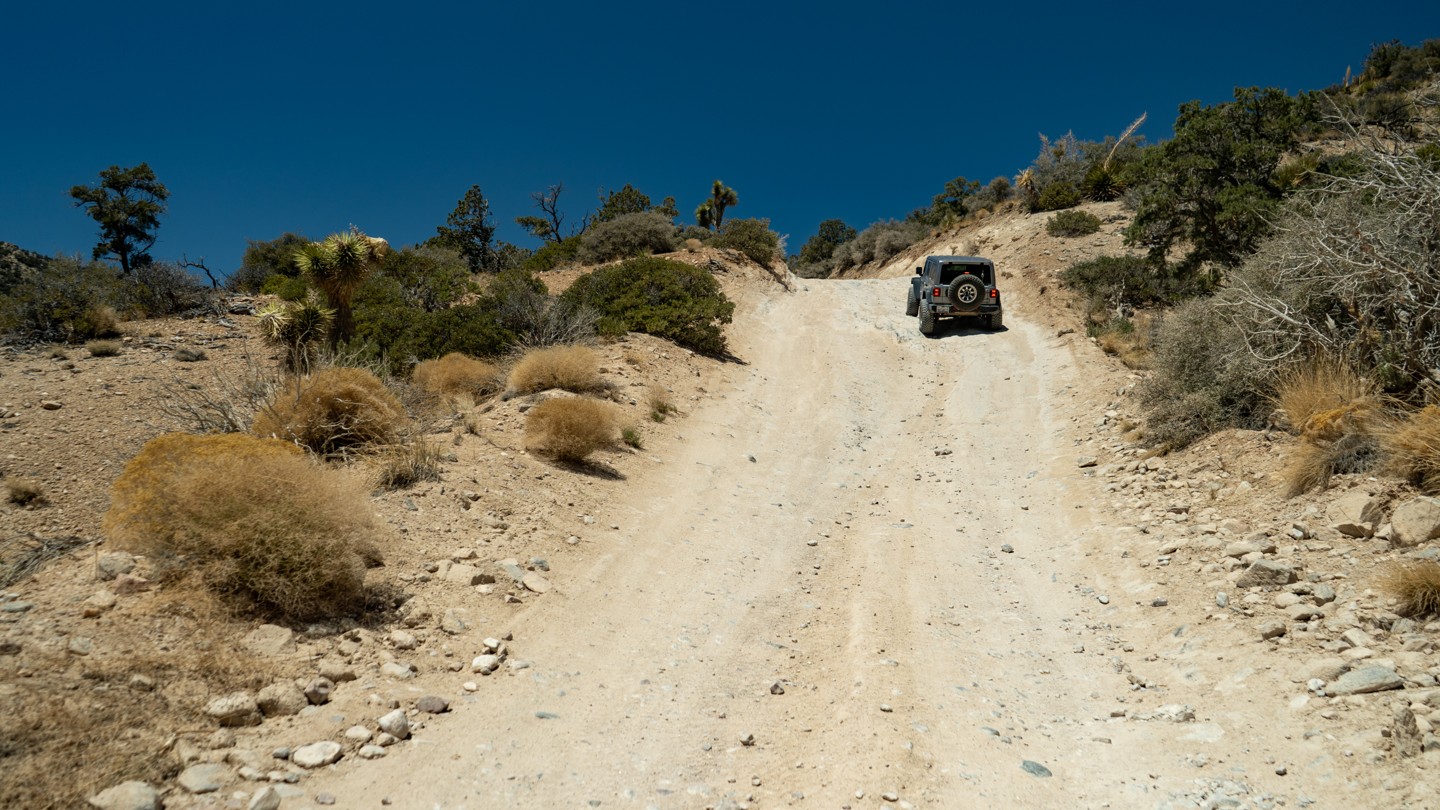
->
560;257;734;355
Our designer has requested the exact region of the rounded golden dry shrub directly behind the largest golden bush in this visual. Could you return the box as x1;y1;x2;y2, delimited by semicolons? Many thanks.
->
251;366;406;455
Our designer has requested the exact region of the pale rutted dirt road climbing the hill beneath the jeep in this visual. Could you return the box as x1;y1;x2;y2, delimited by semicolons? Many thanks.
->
307;280;1339;810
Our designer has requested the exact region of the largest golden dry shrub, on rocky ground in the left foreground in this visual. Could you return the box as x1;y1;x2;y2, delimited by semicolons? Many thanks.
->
102;434;382;620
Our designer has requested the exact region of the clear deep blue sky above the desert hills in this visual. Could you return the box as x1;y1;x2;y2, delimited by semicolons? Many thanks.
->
0;0;1440;271
